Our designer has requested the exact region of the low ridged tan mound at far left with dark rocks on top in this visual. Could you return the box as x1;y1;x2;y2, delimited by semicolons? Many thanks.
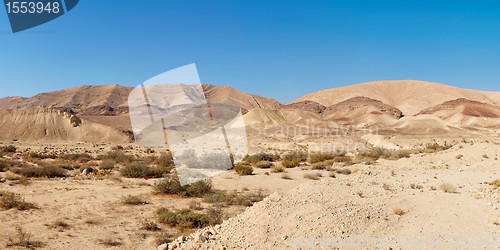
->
0;109;130;143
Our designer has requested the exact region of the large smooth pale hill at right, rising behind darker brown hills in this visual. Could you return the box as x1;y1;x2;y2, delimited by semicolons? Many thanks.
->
294;80;500;116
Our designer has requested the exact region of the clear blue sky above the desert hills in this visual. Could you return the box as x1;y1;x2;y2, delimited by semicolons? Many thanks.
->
0;0;500;102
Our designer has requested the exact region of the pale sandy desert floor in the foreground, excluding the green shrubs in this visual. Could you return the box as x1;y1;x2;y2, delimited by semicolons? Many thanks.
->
0;138;500;249
